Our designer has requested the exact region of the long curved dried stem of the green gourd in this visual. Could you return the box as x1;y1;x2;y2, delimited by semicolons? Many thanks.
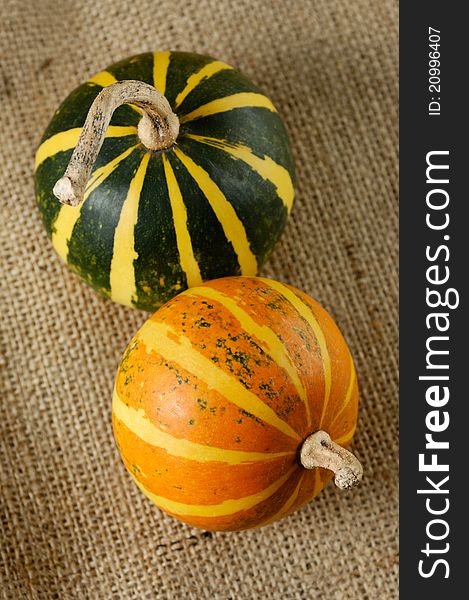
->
53;79;179;206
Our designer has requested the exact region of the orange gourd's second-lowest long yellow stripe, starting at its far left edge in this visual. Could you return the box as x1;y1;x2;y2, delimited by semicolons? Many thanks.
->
112;389;294;469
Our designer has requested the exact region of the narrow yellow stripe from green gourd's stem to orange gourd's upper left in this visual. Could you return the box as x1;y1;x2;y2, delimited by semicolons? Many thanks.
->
163;154;202;287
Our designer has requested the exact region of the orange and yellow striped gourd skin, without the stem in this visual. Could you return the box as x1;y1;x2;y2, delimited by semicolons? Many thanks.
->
113;277;358;530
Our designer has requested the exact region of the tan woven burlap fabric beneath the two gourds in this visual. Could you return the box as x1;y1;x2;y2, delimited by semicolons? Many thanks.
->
0;0;397;600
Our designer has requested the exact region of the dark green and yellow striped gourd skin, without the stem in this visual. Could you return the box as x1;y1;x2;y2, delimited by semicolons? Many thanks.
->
36;52;294;310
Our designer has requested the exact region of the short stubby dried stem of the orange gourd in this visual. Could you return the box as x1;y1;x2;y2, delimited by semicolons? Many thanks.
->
300;431;363;490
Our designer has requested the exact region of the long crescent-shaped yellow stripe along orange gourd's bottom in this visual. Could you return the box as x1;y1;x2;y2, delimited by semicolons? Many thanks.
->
129;466;298;517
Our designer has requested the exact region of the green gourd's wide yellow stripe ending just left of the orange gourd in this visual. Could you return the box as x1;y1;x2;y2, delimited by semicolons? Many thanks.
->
109;152;151;306
